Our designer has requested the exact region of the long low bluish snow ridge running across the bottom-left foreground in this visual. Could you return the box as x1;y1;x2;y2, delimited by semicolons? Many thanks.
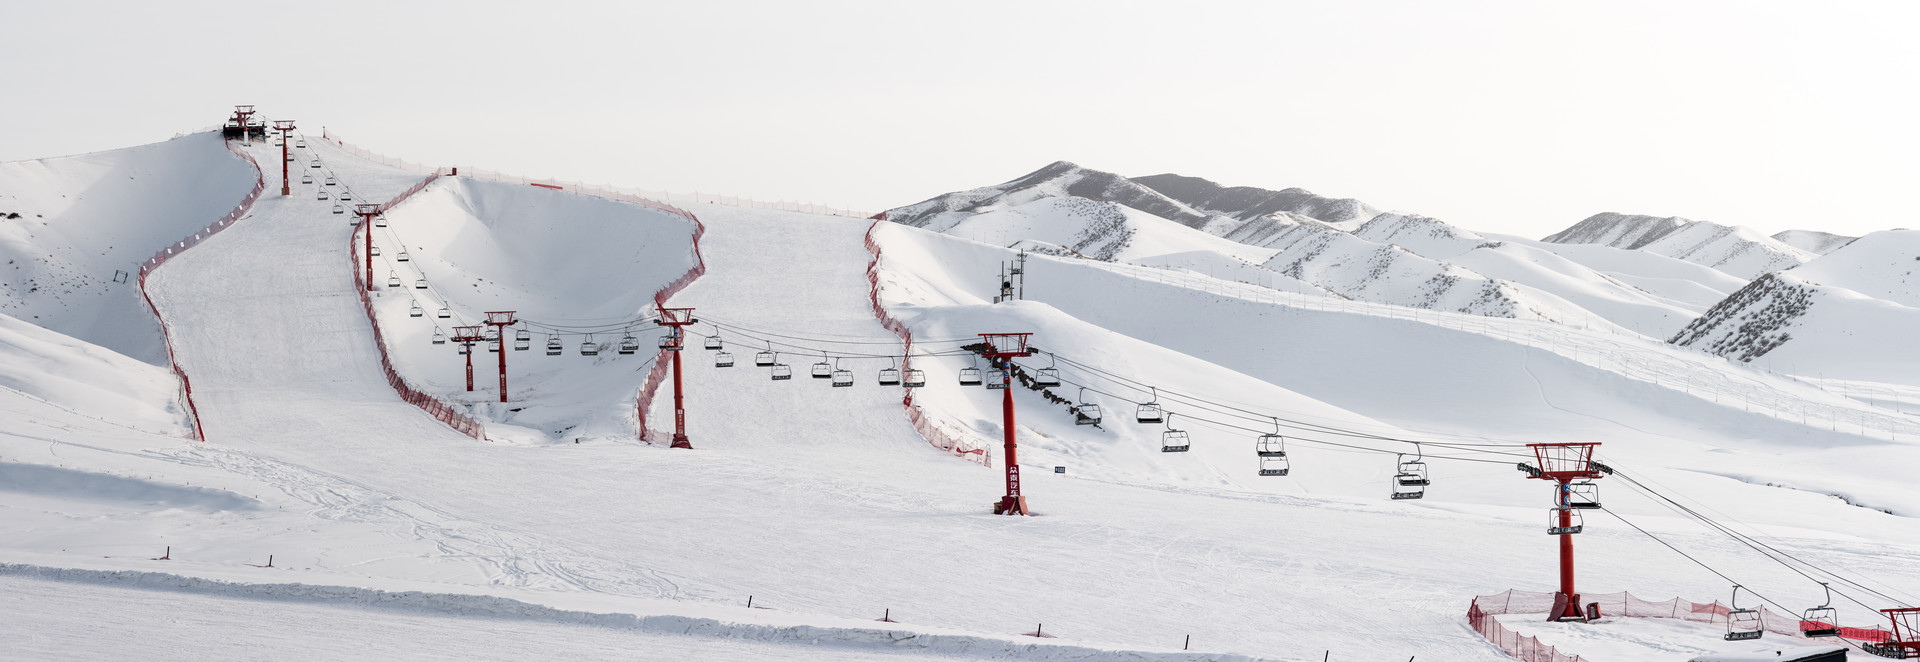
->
0;562;1261;662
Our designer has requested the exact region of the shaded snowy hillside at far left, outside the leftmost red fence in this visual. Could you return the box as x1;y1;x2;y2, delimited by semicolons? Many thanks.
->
0;132;265;365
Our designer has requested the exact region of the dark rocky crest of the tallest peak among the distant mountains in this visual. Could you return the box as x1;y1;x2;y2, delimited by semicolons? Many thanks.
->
887;161;1210;228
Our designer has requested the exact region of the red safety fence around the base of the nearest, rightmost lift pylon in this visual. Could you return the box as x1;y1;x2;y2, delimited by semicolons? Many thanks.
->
1467;591;1893;662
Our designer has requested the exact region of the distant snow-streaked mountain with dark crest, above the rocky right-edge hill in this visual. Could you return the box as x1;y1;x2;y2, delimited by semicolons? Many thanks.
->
1542;211;1814;280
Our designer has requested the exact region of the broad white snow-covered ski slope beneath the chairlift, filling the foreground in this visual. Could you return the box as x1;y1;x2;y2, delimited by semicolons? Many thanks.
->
0;130;1920;662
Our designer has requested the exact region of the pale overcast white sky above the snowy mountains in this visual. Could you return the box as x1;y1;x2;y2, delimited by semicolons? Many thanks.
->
0;0;1920;236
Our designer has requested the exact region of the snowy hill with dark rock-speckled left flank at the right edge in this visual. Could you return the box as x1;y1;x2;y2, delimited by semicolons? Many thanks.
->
1672;269;1920;386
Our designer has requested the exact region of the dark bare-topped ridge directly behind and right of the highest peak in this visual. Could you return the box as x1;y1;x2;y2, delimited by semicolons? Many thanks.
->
1133;173;1380;234
